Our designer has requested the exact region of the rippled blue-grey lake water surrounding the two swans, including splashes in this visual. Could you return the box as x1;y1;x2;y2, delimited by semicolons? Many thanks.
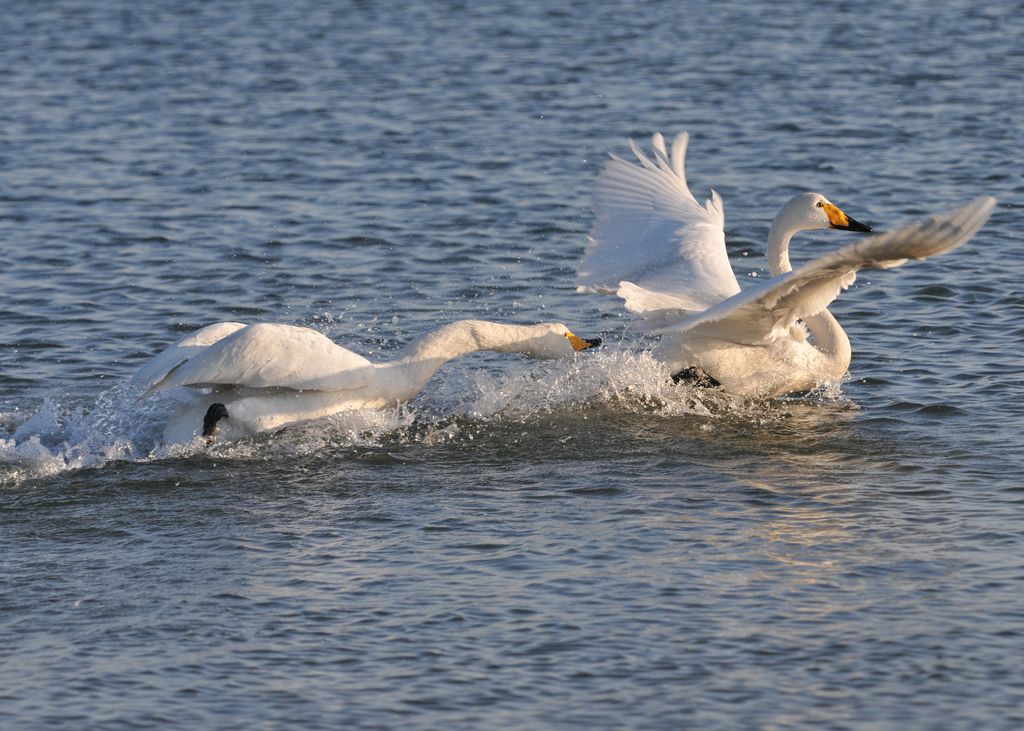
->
0;0;1024;730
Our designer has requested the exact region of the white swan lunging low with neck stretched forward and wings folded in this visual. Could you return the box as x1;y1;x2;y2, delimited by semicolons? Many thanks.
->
133;319;600;443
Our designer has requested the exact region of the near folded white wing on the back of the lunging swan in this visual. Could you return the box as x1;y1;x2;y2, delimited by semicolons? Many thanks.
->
140;323;374;391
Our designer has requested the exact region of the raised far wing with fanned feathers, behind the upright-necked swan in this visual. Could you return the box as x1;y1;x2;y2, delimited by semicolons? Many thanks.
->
577;132;739;312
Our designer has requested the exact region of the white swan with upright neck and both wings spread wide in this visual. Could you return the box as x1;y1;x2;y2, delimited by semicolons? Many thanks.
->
577;127;995;397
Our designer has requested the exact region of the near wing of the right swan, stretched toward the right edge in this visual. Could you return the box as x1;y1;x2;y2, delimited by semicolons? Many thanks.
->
659;197;995;344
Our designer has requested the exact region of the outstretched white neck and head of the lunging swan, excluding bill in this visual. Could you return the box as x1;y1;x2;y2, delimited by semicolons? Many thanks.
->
378;319;557;401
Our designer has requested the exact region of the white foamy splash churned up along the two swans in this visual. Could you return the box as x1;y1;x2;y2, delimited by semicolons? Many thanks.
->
0;349;835;485
